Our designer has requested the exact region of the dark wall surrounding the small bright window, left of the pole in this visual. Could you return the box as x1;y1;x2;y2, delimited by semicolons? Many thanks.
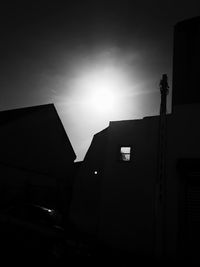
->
71;117;158;254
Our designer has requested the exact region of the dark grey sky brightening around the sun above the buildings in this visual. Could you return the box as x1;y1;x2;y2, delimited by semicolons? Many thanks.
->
0;0;200;161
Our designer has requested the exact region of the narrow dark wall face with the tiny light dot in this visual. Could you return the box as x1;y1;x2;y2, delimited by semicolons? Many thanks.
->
70;129;107;235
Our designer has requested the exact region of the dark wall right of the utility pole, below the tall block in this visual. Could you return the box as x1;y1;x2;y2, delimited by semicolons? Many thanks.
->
166;104;200;260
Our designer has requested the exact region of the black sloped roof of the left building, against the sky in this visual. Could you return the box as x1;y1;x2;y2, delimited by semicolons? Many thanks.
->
0;104;76;175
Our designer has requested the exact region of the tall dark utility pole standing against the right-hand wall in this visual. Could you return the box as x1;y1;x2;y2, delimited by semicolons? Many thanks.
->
155;74;169;259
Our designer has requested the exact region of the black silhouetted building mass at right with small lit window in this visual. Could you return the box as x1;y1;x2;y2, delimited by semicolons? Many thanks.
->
71;18;200;263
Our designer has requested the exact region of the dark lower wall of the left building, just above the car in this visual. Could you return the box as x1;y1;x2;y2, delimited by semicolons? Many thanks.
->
0;164;59;208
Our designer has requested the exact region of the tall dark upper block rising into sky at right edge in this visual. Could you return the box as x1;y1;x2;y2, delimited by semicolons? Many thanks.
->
172;17;200;106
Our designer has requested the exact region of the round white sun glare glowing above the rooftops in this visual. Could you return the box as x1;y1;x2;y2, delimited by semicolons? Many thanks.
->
65;51;136;132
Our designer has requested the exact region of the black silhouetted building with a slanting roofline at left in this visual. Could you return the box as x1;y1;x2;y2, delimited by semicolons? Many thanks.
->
0;104;76;215
